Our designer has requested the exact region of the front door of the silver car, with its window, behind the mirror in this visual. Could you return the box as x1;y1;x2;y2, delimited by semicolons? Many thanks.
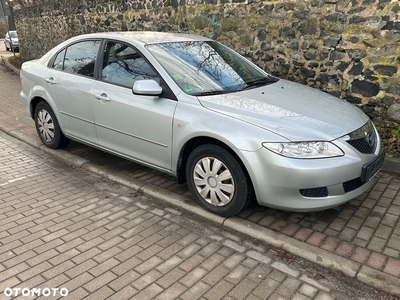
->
93;41;177;170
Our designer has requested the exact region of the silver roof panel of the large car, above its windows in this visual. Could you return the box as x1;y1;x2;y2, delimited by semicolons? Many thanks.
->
69;31;211;45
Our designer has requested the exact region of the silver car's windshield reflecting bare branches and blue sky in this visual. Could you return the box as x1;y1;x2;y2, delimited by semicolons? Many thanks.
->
147;41;278;96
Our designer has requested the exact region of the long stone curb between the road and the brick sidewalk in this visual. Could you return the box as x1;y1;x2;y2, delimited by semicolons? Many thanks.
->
0;121;400;297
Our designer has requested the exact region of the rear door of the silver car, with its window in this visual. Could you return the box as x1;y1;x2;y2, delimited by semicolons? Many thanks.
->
43;40;101;144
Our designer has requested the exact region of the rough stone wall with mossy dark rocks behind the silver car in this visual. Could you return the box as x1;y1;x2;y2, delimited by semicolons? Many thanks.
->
16;0;400;128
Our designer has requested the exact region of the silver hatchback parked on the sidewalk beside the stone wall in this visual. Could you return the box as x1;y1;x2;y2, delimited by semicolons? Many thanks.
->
21;32;385;216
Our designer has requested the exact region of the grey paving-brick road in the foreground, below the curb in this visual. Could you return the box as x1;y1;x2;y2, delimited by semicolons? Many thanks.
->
0;128;394;300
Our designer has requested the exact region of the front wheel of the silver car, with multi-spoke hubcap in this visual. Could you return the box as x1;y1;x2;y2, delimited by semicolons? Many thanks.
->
186;144;252;217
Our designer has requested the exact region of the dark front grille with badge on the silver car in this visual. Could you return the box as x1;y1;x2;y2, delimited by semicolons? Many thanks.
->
347;120;378;154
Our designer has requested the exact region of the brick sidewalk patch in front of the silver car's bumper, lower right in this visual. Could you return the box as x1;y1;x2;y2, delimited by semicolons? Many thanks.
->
236;172;400;278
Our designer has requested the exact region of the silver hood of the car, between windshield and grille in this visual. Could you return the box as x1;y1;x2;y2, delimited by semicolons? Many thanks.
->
199;79;368;141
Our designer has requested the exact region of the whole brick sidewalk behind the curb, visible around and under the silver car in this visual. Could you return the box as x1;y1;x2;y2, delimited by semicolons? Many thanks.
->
0;57;400;298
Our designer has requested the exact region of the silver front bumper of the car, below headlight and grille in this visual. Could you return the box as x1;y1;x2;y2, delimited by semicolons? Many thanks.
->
244;139;384;211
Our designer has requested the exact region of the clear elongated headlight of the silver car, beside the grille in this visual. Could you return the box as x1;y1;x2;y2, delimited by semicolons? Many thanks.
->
262;141;344;159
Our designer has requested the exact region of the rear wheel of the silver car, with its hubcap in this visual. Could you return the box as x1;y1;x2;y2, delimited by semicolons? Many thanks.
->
33;101;69;149
